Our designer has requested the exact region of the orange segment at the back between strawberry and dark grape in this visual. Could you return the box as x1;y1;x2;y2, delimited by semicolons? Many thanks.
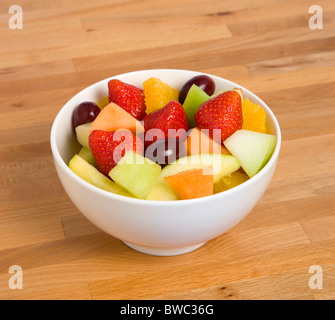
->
143;77;179;114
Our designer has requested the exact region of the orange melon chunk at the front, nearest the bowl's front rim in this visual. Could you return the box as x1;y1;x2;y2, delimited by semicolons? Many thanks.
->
164;168;214;200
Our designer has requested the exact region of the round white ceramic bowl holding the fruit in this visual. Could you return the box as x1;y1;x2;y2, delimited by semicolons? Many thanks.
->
50;69;281;256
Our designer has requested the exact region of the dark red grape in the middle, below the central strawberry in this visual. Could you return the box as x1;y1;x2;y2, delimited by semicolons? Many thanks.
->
145;138;187;167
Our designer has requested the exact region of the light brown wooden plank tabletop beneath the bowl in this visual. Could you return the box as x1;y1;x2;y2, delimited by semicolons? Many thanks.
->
0;0;335;299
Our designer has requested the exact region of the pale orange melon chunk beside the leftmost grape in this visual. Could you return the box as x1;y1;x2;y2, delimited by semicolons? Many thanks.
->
90;102;144;134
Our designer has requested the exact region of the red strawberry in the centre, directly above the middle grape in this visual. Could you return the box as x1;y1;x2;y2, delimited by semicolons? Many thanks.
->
143;100;189;147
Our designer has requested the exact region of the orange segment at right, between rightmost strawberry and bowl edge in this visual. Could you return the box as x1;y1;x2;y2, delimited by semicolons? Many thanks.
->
242;99;266;133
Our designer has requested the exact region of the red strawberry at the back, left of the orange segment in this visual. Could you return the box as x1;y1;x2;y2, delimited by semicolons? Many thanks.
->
108;79;146;120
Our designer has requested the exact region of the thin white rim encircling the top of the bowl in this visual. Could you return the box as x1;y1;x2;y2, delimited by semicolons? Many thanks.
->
50;69;281;207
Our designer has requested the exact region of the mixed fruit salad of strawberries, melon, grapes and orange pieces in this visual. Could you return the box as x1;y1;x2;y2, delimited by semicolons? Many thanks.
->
68;75;276;201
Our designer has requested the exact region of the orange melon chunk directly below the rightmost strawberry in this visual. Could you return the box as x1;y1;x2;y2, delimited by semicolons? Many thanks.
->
185;127;230;156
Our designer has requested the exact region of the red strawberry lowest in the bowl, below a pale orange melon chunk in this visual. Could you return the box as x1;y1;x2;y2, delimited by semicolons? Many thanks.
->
89;130;144;177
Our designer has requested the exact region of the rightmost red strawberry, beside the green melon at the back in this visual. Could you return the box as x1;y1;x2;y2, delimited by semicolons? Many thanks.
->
194;91;243;142
